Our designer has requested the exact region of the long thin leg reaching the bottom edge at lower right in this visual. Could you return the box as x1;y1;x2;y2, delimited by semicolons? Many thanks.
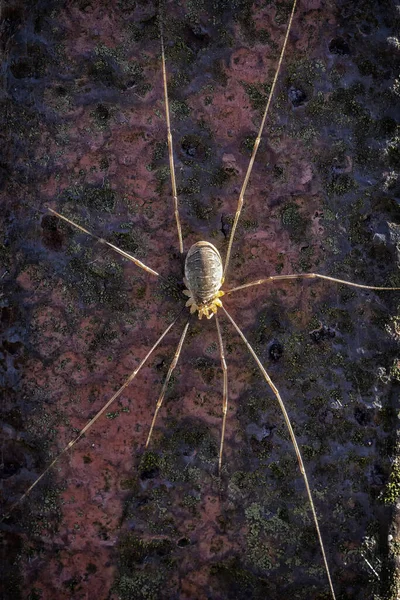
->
222;306;336;600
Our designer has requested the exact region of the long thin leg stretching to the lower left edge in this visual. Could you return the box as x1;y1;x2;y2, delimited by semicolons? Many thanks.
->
0;313;180;522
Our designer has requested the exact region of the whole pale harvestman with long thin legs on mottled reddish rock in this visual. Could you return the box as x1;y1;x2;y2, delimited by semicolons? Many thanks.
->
5;0;400;599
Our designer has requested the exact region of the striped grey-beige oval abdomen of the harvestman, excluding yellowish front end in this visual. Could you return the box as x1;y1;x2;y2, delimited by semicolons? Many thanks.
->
185;242;223;304
